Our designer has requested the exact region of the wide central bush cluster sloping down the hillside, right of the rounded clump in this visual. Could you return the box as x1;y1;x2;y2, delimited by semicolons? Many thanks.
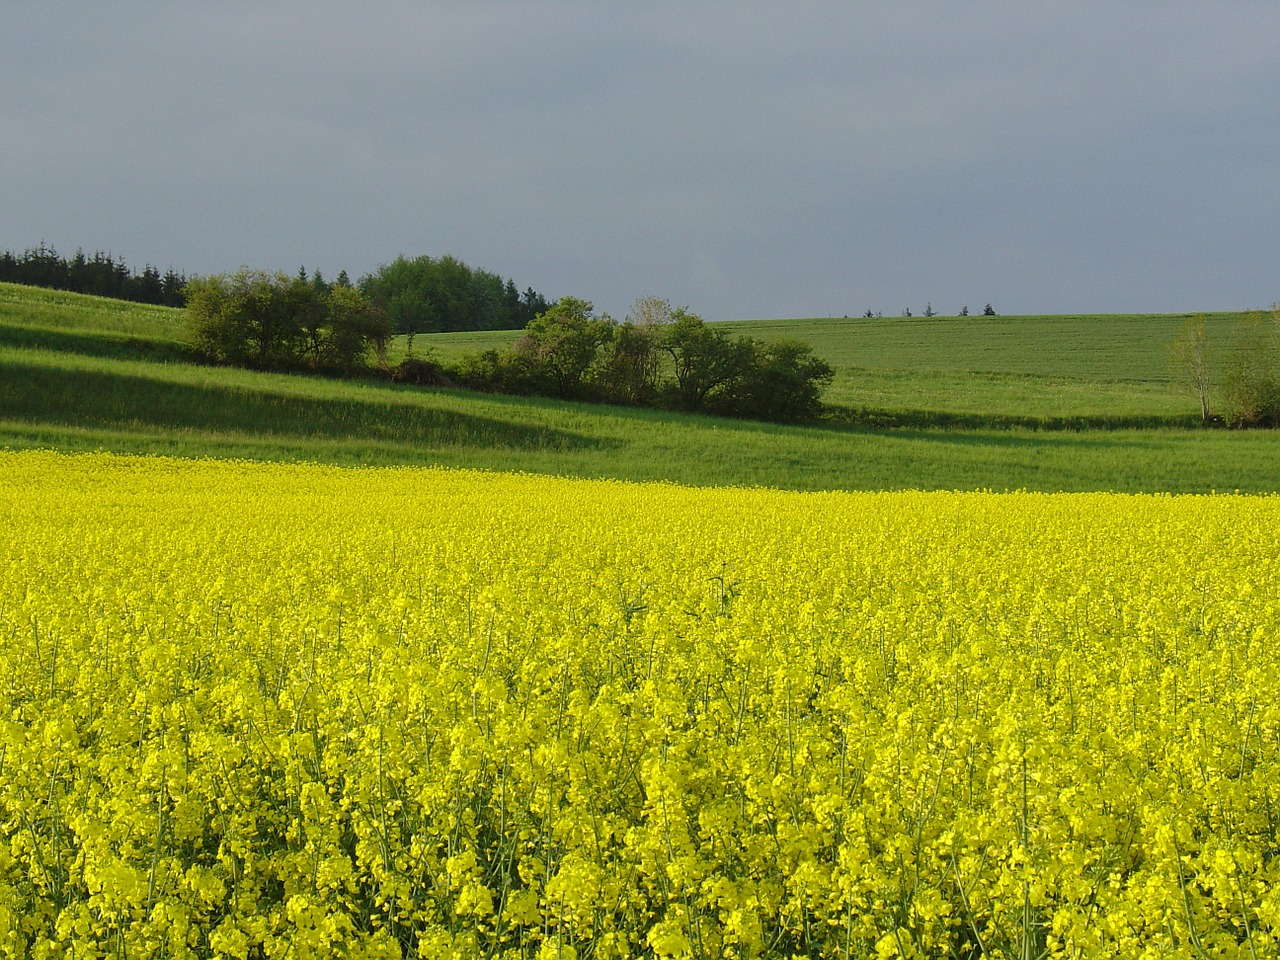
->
445;297;833;421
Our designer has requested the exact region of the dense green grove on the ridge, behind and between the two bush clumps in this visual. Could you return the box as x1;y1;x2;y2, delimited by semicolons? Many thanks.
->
360;256;547;333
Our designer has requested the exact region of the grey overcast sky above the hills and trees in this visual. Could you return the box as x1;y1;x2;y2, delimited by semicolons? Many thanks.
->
0;0;1280;319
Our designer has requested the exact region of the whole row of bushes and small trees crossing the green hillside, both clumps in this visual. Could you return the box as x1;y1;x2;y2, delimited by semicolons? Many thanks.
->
187;268;833;421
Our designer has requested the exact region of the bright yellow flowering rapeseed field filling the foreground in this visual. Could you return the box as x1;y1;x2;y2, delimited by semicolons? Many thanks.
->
0;452;1280;960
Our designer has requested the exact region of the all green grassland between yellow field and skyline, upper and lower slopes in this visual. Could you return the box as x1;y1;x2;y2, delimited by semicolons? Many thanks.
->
0;276;1280;492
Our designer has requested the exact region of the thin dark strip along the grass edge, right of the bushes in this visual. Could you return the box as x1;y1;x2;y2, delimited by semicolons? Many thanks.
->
820;406;1203;431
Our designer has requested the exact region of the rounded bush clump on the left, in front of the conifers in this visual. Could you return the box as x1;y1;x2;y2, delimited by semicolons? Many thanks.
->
187;268;390;372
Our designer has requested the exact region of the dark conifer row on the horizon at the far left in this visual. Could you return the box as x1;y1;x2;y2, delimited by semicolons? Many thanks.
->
0;243;187;307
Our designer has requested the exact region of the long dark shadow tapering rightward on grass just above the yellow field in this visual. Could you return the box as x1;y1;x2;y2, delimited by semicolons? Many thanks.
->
0;362;617;451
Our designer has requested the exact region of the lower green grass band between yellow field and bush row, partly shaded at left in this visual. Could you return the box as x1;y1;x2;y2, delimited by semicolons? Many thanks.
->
0;348;1280;492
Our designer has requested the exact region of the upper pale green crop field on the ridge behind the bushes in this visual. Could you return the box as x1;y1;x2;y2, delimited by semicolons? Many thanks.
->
392;314;1239;426
